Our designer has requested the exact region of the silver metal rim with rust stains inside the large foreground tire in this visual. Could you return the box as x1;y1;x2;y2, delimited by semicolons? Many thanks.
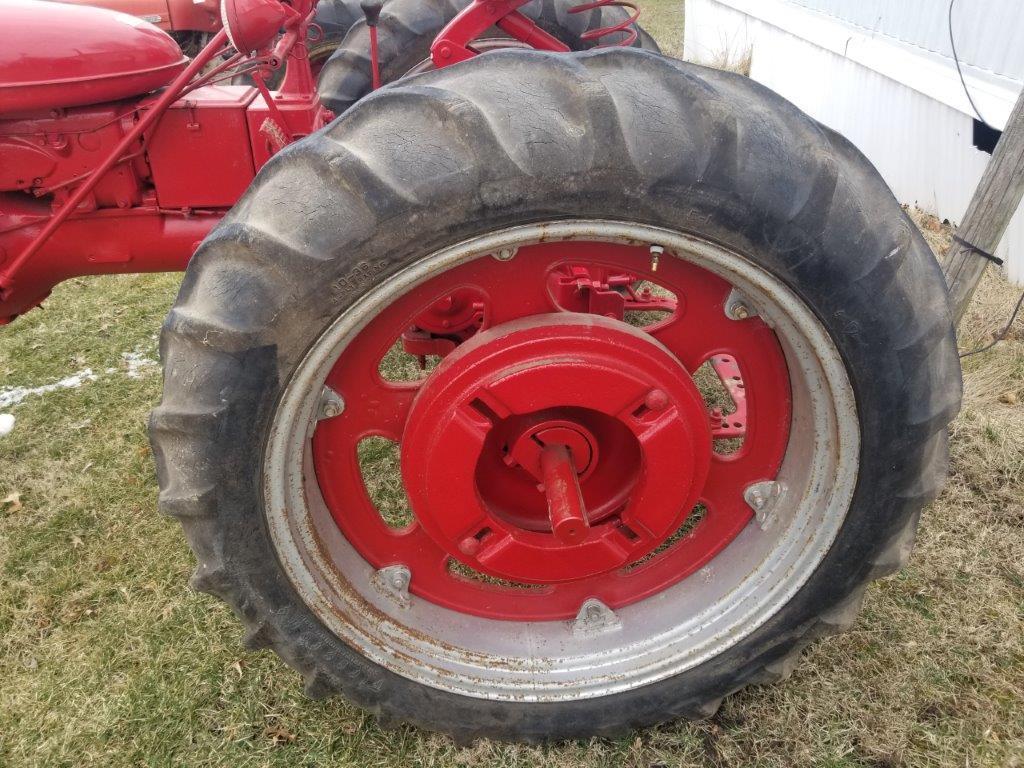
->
263;220;860;701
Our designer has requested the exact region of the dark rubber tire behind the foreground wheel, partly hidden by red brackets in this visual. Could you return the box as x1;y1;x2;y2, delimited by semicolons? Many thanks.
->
317;0;659;115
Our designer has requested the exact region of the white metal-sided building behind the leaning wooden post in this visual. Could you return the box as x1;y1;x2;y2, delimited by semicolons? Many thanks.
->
683;0;1024;283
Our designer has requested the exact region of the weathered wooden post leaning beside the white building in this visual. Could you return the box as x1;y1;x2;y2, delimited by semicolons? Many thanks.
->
942;92;1024;325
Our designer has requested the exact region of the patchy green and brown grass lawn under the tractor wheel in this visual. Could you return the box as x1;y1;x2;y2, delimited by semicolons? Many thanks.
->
0;1;1024;768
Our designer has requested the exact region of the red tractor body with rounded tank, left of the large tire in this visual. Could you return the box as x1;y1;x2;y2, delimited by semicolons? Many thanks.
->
0;0;331;323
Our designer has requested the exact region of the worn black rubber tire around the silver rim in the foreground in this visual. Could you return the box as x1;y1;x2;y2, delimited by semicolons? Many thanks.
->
151;49;961;741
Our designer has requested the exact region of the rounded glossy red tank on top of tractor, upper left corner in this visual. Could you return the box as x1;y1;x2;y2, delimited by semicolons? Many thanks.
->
0;0;187;114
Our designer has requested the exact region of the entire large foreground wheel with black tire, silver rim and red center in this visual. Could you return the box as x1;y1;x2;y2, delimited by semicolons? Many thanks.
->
151;49;961;741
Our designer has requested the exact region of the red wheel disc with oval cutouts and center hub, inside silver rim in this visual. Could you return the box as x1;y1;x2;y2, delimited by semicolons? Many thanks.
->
312;242;791;621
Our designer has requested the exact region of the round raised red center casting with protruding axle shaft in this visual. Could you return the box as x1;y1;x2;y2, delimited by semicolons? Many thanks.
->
401;313;712;584
